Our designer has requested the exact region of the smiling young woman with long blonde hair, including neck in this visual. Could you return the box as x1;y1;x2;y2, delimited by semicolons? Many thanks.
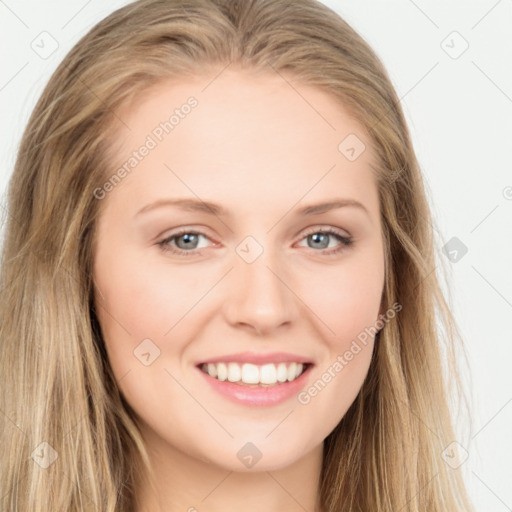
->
0;0;471;512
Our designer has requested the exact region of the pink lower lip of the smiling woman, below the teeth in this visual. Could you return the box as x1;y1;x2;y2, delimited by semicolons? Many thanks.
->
196;365;313;407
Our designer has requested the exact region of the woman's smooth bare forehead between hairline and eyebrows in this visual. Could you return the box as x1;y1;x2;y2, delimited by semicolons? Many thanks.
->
103;69;378;219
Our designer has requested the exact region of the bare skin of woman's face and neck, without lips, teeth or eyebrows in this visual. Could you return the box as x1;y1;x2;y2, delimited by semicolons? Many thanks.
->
94;69;384;512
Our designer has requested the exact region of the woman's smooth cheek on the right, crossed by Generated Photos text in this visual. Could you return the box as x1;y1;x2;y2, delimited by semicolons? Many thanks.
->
298;251;384;424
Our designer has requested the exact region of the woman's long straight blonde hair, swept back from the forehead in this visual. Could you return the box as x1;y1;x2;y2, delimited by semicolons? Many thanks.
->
0;0;472;512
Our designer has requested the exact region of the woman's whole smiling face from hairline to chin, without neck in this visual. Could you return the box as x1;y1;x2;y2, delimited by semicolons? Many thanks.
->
94;70;384;471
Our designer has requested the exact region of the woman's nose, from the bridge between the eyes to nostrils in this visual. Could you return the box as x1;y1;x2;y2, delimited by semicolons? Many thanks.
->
223;251;298;335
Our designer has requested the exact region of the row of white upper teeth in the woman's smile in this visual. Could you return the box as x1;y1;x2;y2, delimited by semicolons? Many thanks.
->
201;362;304;385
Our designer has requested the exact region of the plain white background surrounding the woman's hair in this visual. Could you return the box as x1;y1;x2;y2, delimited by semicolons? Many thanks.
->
0;0;512;512
